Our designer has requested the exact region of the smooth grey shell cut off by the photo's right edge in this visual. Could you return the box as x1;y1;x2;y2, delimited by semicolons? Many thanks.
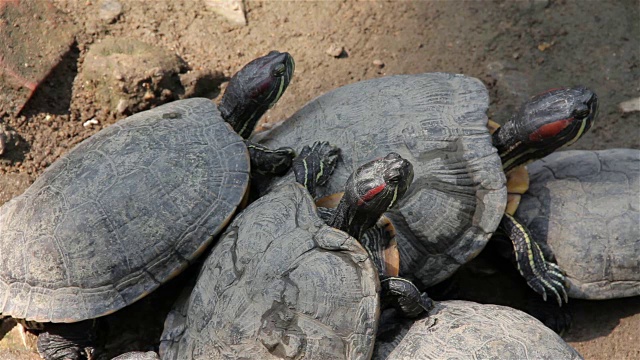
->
516;149;640;299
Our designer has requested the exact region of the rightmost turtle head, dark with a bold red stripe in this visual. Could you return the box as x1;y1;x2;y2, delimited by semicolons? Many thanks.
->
493;87;598;171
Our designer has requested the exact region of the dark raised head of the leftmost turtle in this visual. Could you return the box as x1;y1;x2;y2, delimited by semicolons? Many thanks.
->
219;51;295;139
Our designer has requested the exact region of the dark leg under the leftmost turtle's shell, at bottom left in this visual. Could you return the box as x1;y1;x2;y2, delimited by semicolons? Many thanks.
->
37;320;95;360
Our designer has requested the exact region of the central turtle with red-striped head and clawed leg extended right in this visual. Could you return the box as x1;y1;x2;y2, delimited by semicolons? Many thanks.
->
252;73;598;303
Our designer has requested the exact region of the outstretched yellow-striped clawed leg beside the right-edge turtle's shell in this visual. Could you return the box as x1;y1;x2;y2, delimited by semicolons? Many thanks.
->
499;213;569;306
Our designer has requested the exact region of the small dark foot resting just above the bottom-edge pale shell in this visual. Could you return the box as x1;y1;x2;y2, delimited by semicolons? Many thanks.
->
380;276;433;318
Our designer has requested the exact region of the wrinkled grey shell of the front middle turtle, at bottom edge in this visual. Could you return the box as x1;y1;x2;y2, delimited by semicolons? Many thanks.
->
160;184;380;360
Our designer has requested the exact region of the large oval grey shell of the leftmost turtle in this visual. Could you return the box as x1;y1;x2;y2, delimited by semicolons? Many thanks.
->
0;98;250;322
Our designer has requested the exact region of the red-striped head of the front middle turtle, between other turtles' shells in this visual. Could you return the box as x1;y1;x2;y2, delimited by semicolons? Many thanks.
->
331;153;413;239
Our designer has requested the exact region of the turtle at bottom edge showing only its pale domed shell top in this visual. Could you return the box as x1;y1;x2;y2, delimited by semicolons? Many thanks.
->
373;300;582;360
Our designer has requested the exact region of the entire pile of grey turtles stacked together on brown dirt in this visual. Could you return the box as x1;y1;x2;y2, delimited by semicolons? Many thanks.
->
0;51;640;360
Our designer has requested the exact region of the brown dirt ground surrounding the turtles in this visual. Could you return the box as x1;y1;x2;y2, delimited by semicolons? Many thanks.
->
0;0;640;359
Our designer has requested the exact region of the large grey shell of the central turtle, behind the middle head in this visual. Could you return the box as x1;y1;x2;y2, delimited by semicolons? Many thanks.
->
260;73;507;288
